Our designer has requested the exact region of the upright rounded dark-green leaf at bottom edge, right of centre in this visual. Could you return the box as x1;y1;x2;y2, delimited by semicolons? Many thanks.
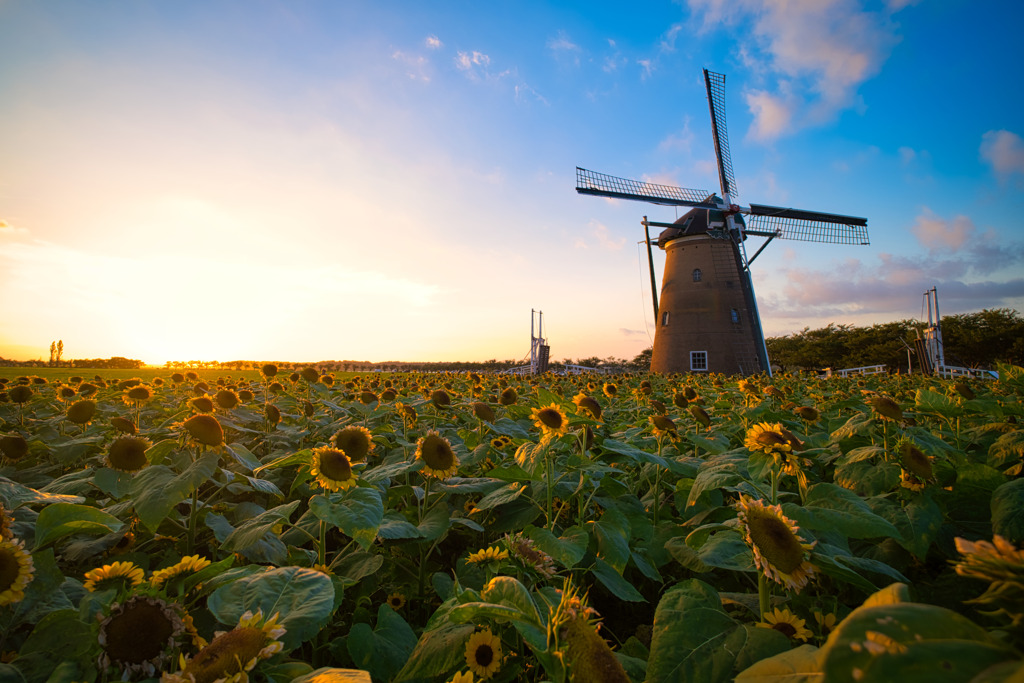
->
647;579;737;683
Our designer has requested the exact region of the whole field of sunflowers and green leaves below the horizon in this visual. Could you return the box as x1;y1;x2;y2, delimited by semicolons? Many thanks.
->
0;365;1024;683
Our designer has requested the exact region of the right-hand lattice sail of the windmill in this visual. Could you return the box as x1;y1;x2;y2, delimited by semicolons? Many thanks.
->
744;204;870;245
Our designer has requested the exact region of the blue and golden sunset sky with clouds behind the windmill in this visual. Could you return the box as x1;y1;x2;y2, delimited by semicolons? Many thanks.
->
0;0;1024;365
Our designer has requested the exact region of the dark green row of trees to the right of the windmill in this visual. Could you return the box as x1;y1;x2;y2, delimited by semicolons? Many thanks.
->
765;308;1024;372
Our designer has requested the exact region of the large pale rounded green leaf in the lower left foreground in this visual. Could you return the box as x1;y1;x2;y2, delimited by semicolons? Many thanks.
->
207;566;334;651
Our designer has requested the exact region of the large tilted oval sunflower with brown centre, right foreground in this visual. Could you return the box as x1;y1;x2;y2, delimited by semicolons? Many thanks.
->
738;495;816;593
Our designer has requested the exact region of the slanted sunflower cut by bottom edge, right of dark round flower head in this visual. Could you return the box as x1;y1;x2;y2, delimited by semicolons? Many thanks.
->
160;610;285;683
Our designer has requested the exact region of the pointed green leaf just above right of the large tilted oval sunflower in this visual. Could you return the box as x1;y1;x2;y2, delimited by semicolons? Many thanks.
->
782;482;900;539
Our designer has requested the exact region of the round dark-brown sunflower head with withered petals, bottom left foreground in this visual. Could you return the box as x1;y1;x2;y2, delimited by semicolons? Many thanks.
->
97;595;187;680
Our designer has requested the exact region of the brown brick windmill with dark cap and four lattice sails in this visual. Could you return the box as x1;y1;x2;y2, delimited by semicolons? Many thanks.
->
577;69;868;375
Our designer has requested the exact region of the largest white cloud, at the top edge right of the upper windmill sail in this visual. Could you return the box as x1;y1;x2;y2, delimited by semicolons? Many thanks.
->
689;0;899;139
